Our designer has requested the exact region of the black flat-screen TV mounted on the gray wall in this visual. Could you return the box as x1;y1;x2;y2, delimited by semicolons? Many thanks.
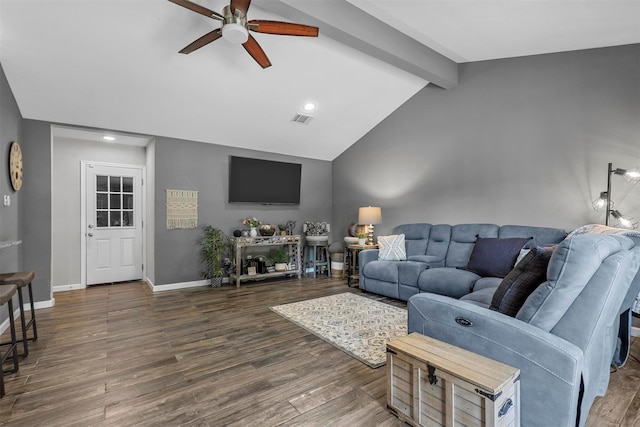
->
229;156;302;205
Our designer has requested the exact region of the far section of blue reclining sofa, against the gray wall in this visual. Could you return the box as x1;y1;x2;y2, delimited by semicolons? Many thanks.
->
359;224;567;301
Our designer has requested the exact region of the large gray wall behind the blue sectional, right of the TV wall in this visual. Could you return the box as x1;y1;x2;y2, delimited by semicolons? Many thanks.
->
333;45;640;234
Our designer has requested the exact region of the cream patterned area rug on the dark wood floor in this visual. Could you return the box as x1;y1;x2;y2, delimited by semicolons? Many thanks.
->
271;292;407;368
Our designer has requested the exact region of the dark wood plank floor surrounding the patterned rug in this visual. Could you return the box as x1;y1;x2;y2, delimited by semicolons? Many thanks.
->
0;278;640;427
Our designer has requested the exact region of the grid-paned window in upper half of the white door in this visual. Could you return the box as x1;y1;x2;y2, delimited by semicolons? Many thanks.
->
96;175;136;227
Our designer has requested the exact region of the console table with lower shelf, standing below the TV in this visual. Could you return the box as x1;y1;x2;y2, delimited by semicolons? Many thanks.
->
231;235;302;288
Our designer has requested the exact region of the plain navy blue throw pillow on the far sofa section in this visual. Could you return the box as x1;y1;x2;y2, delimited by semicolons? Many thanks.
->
467;237;530;277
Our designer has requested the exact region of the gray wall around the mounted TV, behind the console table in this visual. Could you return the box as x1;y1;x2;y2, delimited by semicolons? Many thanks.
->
154;137;332;285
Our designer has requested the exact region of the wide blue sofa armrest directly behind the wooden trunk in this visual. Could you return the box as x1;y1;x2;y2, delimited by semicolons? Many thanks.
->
407;293;584;426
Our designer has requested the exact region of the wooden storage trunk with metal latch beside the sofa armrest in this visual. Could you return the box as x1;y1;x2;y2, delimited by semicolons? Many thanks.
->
387;333;520;427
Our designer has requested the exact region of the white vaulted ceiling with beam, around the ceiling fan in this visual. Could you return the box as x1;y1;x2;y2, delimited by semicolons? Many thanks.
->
0;0;640;160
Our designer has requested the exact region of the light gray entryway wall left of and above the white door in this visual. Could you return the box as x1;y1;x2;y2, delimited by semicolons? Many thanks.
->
51;138;146;287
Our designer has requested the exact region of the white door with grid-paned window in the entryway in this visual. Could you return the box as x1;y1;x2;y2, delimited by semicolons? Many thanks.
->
85;164;142;285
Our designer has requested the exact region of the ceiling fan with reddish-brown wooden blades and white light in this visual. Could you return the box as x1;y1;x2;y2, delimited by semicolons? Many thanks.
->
169;0;318;68
